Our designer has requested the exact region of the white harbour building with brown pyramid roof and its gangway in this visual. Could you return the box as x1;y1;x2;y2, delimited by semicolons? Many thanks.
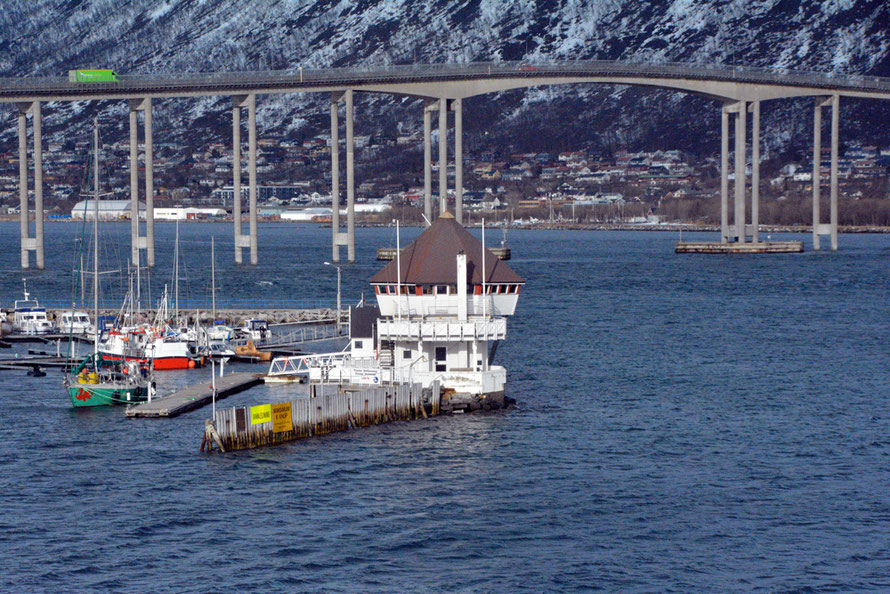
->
270;212;525;408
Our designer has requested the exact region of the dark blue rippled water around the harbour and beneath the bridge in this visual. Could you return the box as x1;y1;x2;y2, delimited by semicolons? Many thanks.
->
0;224;890;591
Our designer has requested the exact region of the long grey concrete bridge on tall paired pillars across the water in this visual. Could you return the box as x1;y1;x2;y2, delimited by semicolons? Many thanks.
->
0;61;890;268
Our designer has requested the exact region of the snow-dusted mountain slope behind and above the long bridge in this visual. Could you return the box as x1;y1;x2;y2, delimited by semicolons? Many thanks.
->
0;0;890;151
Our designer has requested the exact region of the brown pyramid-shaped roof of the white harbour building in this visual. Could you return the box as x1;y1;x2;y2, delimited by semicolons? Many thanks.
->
371;211;525;285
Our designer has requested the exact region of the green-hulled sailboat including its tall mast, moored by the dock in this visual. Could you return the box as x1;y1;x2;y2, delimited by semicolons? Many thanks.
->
64;121;154;407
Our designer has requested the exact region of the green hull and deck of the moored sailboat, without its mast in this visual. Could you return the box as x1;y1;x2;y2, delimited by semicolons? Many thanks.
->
65;354;154;407
